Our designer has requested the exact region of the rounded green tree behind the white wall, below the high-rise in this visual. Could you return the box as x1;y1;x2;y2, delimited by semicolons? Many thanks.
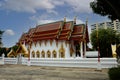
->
91;28;118;57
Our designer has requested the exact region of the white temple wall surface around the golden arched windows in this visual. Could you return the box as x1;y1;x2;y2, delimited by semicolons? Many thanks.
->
30;40;70;58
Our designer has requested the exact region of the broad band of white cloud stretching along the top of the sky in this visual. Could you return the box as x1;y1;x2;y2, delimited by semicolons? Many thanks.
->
1;0;93;14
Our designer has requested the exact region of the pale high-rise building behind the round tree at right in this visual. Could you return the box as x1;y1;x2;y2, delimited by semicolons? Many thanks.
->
91;20;120;32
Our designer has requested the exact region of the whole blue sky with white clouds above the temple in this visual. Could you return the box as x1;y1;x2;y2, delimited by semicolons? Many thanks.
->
0;0;109;47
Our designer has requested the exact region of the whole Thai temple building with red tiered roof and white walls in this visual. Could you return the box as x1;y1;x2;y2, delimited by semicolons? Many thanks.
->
8;18;89;58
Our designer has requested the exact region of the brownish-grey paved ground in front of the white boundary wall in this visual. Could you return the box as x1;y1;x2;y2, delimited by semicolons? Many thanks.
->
0;65;109;80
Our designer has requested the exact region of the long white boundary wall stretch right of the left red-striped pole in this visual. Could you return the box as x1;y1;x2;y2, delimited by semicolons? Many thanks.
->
30;58;117;68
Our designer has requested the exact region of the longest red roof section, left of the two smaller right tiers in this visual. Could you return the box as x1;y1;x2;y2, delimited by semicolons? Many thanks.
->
32;21;63;41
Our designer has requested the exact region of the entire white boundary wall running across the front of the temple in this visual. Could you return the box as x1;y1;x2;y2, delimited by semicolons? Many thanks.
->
0;52;117;68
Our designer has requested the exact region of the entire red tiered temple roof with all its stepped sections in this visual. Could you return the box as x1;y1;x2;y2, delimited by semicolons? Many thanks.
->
20;21;86;43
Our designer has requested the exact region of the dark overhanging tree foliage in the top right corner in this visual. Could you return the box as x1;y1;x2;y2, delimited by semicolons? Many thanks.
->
90;0;120;20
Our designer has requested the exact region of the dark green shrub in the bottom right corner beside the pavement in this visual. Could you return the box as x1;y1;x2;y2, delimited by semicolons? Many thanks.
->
108;67;120;80
